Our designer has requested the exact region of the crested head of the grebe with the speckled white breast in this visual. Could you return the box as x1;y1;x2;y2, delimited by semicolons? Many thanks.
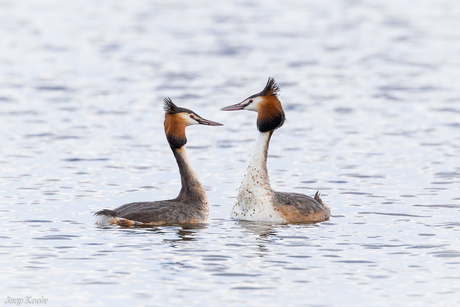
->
221;77;285;132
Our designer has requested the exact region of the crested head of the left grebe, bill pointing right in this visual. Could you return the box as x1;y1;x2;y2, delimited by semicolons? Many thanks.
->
163;97;222;148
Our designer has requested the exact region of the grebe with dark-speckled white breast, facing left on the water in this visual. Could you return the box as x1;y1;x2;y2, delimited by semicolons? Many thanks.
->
221;78;331;223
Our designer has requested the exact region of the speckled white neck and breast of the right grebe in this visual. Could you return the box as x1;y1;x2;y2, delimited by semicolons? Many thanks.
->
232;131;284;222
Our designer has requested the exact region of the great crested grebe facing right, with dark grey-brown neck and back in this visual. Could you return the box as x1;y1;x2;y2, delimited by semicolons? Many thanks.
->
95;98;222;226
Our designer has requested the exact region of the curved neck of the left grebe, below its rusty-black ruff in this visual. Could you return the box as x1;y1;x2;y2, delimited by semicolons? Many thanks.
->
171;145;207;203
